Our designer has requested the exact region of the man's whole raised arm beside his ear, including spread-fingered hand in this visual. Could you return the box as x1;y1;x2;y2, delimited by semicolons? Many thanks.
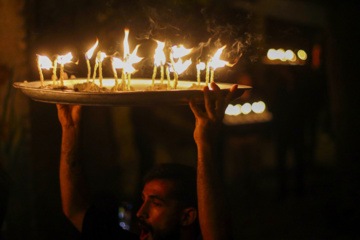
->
190;83;237;240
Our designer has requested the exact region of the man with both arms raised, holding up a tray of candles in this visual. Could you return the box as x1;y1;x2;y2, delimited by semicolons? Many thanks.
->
57;83;237;240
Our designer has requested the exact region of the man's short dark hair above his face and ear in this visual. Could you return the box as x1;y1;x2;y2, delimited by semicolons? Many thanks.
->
143;163;197;209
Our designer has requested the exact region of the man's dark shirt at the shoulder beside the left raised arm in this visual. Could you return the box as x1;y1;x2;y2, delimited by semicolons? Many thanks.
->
81;205;139;240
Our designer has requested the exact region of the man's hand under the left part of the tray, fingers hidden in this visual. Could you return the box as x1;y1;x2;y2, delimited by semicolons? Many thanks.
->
56;104;81;130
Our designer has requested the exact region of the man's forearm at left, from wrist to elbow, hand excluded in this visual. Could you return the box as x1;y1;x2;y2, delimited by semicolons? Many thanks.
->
60;127;90;231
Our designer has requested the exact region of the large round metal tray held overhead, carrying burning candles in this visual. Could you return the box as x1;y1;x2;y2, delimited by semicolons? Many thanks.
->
13;79;251;106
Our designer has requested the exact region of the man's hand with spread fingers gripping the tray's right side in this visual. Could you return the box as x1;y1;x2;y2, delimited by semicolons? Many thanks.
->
189;82;237;145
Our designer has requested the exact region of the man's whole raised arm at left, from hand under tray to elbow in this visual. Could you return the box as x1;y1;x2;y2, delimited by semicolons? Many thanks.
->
57;104;90;232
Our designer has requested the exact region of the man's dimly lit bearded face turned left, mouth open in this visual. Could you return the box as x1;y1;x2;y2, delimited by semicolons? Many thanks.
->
136;180;182;240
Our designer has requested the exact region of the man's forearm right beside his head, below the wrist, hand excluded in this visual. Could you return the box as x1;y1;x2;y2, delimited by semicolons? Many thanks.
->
197;142;232;240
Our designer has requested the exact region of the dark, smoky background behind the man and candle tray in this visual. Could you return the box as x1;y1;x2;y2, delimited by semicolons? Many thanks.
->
0;0;360;239
